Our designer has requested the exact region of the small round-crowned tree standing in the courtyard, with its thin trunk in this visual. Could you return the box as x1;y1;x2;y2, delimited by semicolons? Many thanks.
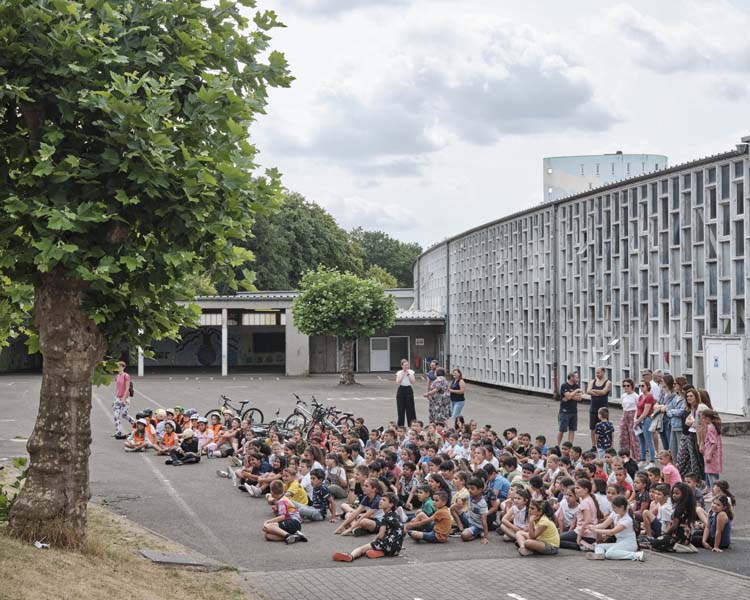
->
292;267;396;385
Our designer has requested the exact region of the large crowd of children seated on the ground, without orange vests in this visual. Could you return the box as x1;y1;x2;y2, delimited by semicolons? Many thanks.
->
198;417;734;562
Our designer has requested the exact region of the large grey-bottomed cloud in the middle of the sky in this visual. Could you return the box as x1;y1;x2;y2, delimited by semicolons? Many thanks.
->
271;17;617;176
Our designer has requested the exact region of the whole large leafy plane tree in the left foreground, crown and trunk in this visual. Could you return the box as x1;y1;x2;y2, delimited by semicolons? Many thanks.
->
0;0;291;547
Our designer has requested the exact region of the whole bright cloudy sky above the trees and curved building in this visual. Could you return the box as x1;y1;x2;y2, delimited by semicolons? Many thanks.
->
253;0;750;246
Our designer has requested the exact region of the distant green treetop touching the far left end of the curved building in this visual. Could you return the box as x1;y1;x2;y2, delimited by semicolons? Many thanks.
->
351;227;422;288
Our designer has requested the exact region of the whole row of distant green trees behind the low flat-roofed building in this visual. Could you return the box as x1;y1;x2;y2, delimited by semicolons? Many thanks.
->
236;193;422;292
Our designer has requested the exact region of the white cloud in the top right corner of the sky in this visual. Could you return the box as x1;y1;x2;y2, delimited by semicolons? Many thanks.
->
609;2;750;73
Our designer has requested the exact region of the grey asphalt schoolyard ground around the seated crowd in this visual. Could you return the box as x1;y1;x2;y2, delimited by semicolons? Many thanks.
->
0;373;750;600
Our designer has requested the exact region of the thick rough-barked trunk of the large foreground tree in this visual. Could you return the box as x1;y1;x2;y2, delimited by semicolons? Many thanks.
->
9;269;106;548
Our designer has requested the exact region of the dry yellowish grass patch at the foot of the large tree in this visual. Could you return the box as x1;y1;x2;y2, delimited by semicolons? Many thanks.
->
0;474;252;600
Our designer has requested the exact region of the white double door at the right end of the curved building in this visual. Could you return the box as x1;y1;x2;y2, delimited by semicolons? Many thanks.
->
704;340;745;415
